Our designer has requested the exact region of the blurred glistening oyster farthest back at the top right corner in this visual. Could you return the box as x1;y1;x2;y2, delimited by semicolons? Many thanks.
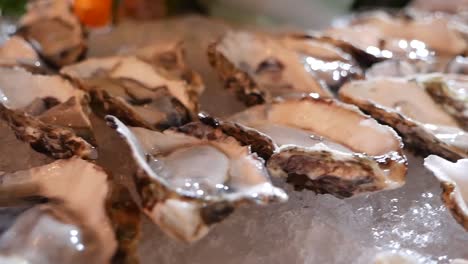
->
324;12;468;66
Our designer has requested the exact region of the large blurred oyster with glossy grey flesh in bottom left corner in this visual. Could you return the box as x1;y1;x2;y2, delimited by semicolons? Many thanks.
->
0;158;138;264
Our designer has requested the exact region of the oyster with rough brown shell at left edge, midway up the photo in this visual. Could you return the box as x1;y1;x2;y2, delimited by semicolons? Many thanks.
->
0;68;97;159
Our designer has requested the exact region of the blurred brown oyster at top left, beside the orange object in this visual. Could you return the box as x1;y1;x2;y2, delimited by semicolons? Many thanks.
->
16;0;86;68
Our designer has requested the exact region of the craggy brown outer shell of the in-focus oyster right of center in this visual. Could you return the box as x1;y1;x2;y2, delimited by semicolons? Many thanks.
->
199;96;407;198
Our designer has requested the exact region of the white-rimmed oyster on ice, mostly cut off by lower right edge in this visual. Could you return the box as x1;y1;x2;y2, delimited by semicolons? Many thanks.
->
424;155;468;231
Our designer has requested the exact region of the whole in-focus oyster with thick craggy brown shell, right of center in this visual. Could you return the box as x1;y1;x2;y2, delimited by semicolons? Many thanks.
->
202;96;406;198
